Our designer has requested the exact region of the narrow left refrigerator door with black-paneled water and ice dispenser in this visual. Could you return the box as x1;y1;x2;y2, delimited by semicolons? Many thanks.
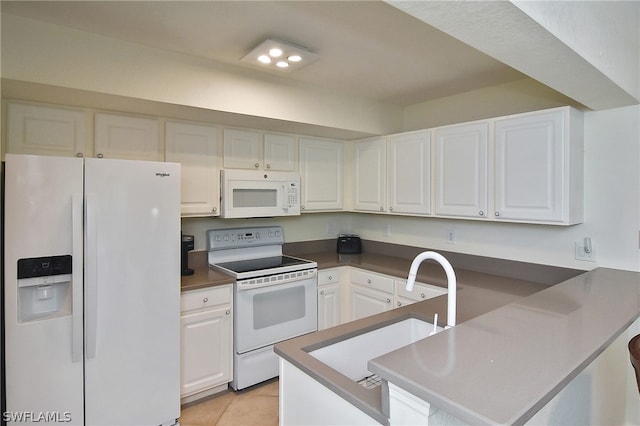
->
3;154;84;425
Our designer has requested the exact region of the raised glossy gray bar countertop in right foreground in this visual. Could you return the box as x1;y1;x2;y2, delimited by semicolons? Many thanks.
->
369;268;640;424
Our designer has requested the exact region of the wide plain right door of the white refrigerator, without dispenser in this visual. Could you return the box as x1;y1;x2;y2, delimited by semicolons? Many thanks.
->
85;159;180;425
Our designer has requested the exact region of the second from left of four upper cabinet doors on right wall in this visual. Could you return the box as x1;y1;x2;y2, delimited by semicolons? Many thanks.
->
387;131;431;214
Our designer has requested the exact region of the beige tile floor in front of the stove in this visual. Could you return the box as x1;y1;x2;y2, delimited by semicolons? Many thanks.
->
180;379;278;426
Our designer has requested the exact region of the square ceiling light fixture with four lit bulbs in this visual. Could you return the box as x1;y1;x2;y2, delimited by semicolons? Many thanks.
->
240;39;319;72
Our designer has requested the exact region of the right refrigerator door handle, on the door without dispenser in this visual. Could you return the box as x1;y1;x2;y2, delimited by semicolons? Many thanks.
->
84;194;98;358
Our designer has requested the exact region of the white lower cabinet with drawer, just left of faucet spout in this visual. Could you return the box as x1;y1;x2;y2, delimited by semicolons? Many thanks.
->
349;269;393;321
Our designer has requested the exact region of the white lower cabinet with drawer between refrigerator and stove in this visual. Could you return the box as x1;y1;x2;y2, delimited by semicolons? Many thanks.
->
180;285;233;403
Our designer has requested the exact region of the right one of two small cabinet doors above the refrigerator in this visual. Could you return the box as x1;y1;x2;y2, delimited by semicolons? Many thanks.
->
95;113;162;161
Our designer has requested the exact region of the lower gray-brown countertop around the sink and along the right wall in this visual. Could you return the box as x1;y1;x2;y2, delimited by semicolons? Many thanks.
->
274;252;560;424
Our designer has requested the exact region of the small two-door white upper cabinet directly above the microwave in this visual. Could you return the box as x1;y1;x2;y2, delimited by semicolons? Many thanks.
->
223;129;298;172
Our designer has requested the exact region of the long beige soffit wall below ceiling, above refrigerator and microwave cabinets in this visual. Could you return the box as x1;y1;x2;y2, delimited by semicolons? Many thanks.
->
2;14;402;138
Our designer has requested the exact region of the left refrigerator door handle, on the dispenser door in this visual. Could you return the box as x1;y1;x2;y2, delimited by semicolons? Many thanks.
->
71;194;83;362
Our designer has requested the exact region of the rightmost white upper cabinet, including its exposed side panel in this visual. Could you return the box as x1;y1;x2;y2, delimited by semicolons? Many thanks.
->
494;107;584;225
